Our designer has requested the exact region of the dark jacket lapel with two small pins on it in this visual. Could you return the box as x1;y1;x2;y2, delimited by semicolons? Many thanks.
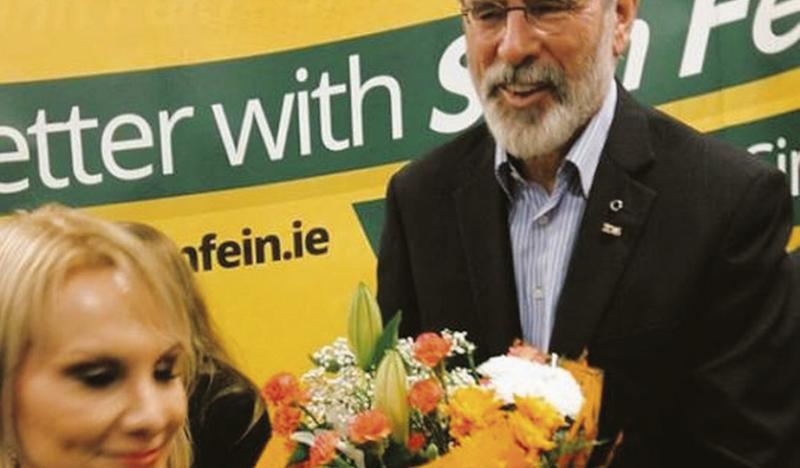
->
550;88;657;357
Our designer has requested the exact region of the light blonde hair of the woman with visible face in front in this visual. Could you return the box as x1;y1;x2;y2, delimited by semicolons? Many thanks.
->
0;205;195;468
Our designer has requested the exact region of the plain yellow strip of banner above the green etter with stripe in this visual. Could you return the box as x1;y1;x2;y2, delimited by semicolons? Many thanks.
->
0;0;458;83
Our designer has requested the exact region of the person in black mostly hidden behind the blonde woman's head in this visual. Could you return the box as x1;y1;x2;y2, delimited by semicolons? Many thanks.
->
122;223;270;468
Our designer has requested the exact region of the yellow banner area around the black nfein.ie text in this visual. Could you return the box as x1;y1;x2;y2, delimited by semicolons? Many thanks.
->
90;165;406;383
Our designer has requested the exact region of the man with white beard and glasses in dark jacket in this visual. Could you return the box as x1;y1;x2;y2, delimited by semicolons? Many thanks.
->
378;0;800;468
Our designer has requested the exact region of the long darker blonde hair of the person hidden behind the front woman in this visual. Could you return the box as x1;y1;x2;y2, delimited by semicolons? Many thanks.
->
120;222;266;437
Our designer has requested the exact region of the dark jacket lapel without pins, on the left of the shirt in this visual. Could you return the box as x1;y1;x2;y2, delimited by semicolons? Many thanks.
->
453;127;522;356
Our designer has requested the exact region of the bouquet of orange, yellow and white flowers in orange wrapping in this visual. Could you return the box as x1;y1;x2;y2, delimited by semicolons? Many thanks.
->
263;284;602;468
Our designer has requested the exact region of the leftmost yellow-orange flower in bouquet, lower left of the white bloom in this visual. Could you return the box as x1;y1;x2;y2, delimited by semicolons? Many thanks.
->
446;387;504;442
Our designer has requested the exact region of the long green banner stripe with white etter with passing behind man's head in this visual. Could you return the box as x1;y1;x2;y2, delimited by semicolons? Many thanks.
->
0;8;800;213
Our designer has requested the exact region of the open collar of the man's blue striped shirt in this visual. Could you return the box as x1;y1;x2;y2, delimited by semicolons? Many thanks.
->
494;80;617;200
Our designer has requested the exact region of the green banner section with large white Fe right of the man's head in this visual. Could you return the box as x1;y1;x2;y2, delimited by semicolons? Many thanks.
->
627;0;800;104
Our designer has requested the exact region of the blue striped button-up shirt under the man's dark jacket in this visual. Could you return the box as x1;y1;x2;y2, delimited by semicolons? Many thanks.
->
495;80;617;351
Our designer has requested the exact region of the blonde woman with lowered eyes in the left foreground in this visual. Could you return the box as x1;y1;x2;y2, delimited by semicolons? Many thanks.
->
0;206;194;468
